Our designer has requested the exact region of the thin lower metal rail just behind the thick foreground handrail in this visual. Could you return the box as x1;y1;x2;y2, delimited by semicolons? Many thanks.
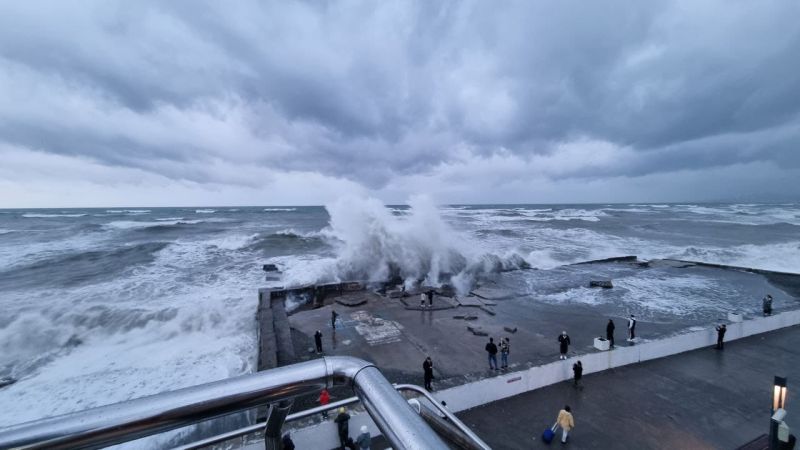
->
173;384;491;450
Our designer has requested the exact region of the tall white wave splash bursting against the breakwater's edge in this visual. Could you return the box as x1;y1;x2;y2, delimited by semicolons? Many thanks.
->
285;195;529;293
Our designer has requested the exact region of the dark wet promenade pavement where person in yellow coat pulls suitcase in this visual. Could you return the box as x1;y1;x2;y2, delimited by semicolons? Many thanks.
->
458;326;800;450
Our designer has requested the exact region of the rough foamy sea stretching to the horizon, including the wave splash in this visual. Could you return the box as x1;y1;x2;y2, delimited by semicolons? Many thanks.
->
0;201;800;445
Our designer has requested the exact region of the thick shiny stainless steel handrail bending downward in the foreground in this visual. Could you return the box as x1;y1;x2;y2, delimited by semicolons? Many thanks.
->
0;356;448;450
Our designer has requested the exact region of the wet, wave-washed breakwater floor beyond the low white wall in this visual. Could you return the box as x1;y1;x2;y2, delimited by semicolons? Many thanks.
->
289;261;800;389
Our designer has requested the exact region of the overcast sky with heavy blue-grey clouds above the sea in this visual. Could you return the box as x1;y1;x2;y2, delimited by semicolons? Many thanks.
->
0;0;800;207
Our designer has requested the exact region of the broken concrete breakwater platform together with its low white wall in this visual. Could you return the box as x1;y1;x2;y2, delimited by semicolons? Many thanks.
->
259;256;800;448
